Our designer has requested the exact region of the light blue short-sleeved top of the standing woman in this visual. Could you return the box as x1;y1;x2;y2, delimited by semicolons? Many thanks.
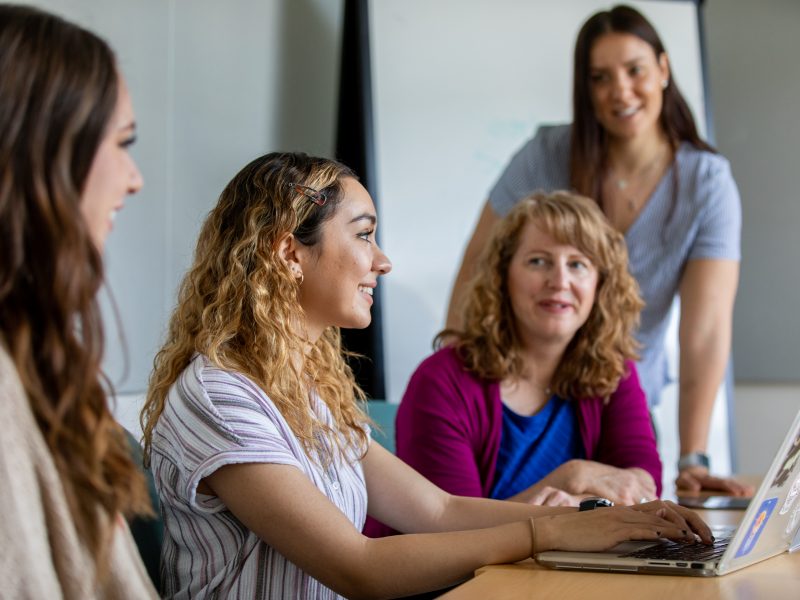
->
489;125;742;406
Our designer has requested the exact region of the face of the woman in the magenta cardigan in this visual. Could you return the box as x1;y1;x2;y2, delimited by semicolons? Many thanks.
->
508;222;598;351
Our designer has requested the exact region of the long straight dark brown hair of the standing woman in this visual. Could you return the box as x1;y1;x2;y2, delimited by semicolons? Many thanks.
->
570;5;716;206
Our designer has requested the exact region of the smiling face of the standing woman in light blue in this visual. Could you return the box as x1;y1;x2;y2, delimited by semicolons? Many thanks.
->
589;33;669;144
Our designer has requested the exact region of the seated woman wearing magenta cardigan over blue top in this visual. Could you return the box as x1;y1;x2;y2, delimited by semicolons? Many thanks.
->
396;192;661;505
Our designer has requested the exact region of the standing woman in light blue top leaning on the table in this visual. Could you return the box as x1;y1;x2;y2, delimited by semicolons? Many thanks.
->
447;6;752;494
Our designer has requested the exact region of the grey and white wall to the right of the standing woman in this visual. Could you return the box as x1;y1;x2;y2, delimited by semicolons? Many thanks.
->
705;0;800;473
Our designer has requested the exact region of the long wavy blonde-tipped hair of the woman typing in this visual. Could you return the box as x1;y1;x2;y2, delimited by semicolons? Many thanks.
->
140;153;368;460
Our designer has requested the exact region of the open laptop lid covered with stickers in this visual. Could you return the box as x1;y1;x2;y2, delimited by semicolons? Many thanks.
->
718;412;800;574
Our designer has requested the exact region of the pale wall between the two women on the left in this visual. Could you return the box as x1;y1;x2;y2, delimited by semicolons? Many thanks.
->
27;0;343;431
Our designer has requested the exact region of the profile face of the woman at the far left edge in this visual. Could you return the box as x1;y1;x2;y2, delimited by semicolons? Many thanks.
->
81;76;142;251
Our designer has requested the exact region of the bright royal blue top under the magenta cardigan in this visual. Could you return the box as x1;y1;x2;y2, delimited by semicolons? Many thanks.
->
490;395;584;500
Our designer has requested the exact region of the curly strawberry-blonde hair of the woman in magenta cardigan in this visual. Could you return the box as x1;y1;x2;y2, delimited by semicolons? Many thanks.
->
444;191;644;399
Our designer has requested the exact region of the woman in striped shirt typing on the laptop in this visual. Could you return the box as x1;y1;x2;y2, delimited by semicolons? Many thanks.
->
142;153;710;599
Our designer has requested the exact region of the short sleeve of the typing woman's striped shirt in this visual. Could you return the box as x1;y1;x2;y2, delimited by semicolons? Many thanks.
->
159;359;303;512
